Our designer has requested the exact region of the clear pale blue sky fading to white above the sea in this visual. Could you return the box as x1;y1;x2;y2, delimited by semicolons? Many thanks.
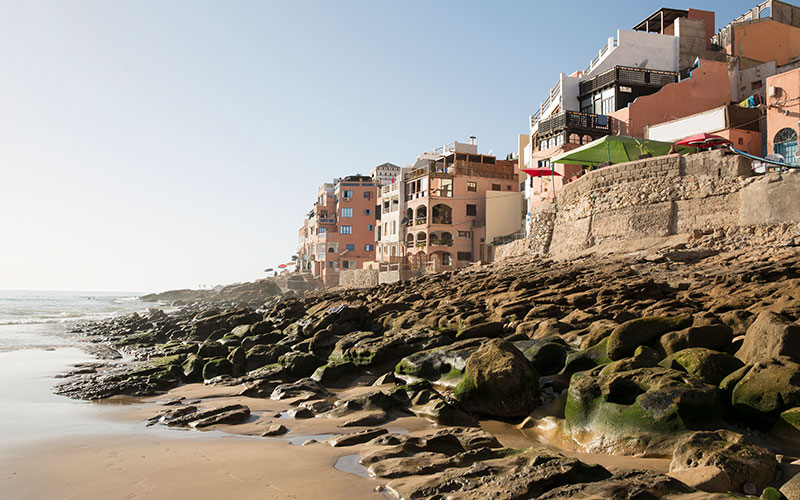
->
0;0;757;292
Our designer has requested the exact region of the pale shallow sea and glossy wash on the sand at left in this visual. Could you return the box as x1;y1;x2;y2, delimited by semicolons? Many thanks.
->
0;291;150;458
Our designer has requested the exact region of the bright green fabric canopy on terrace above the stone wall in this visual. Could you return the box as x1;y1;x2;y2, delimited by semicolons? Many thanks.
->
550;135;694;167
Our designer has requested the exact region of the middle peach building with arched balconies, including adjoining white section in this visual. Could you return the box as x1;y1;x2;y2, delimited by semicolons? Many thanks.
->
378;139;521;270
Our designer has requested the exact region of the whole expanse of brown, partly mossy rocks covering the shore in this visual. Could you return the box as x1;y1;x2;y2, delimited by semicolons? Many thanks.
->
56;247;800;500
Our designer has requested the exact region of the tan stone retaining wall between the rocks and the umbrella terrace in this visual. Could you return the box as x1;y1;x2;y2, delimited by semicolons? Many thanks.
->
495;150;800;260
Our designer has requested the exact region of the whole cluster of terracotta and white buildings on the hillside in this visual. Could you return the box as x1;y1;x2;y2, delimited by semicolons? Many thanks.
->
294;0;800;286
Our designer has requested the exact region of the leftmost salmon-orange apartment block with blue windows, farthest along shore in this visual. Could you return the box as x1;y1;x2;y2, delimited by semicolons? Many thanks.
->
297;175;379;286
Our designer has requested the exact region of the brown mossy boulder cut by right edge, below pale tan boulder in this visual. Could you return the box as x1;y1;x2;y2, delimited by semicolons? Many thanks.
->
726;356;800;428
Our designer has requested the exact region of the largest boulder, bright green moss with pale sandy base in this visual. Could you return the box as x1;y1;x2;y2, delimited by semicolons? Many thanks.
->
564;364;721;455
